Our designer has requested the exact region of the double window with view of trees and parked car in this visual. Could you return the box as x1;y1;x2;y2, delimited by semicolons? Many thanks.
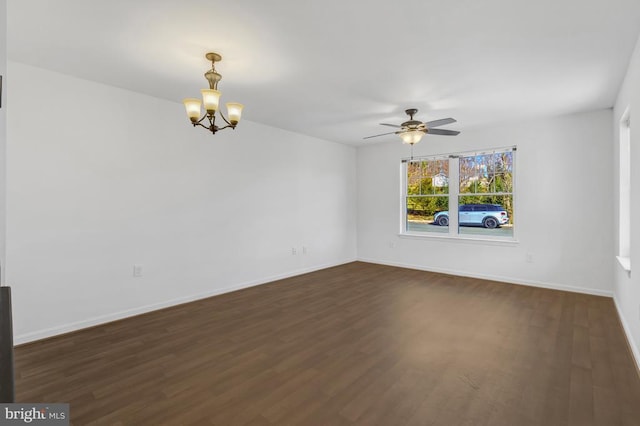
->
402;147;515;239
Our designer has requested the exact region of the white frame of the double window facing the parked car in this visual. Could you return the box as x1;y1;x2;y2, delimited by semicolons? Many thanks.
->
398;146;518;244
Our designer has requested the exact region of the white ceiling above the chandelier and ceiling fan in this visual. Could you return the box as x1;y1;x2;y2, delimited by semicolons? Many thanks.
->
7;0;640;145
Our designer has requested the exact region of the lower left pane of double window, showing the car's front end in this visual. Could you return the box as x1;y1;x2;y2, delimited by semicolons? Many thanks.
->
407;195;449;233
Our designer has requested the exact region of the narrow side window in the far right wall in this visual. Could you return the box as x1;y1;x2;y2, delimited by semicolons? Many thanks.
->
617;108;631;271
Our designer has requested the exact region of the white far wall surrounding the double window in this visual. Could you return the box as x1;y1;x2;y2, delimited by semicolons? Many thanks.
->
357;109;613;295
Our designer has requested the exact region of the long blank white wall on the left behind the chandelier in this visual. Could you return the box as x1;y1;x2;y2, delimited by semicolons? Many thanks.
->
7;61;356;343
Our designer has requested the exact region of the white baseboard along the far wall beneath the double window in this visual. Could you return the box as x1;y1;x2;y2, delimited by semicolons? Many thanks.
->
358;258;613;297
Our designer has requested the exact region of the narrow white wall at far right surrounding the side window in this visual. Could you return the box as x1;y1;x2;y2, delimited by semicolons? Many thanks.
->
611;33;640;367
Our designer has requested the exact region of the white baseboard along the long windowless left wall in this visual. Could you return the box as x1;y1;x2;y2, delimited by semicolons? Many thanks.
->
13;258;357;346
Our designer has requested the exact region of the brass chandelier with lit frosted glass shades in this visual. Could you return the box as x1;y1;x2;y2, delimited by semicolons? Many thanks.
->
182;52;243;134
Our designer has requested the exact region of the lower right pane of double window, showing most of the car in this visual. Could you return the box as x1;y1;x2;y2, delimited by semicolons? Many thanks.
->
458;194;513;237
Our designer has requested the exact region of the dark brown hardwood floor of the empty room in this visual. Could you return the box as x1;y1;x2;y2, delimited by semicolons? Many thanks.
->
15;262;640;426
